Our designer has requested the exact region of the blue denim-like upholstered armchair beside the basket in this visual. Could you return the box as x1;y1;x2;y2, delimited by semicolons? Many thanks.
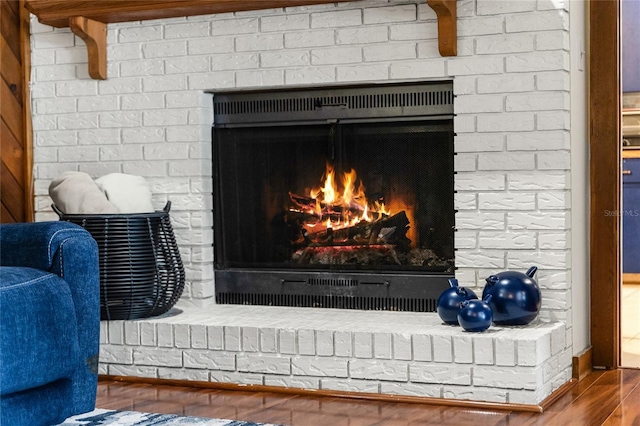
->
0;222;100;426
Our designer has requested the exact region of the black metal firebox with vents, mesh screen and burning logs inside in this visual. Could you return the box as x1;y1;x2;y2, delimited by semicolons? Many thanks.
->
212;82;455;312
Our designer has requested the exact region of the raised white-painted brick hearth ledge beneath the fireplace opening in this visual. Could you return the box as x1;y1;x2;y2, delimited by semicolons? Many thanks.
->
100;303;572;406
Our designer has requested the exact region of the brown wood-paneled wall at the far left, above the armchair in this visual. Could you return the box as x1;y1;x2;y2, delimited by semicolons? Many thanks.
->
0;0;33;223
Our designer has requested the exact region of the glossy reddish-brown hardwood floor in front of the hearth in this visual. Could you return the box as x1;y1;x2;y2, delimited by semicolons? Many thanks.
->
96;369;640;426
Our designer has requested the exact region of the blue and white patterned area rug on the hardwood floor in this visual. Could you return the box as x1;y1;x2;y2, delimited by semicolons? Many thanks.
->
58;409;282;426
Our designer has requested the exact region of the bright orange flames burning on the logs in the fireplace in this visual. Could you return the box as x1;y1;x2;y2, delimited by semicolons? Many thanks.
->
298;164;390;232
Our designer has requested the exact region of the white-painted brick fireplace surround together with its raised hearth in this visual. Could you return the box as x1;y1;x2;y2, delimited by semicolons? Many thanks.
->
31;0;588;404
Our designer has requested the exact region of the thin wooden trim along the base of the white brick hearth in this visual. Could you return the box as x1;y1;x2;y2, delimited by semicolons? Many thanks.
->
99;375;577;413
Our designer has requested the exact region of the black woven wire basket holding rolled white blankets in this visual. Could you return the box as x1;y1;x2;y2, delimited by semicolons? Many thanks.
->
51;201;185;320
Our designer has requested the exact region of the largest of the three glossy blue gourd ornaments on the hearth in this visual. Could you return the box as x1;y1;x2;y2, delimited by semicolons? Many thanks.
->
482;266;541;325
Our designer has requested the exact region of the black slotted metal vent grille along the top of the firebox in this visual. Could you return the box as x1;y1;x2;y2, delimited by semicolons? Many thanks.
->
213;82;453;126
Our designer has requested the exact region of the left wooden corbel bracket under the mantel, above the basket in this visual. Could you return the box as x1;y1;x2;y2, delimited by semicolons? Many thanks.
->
69;16;107;80
